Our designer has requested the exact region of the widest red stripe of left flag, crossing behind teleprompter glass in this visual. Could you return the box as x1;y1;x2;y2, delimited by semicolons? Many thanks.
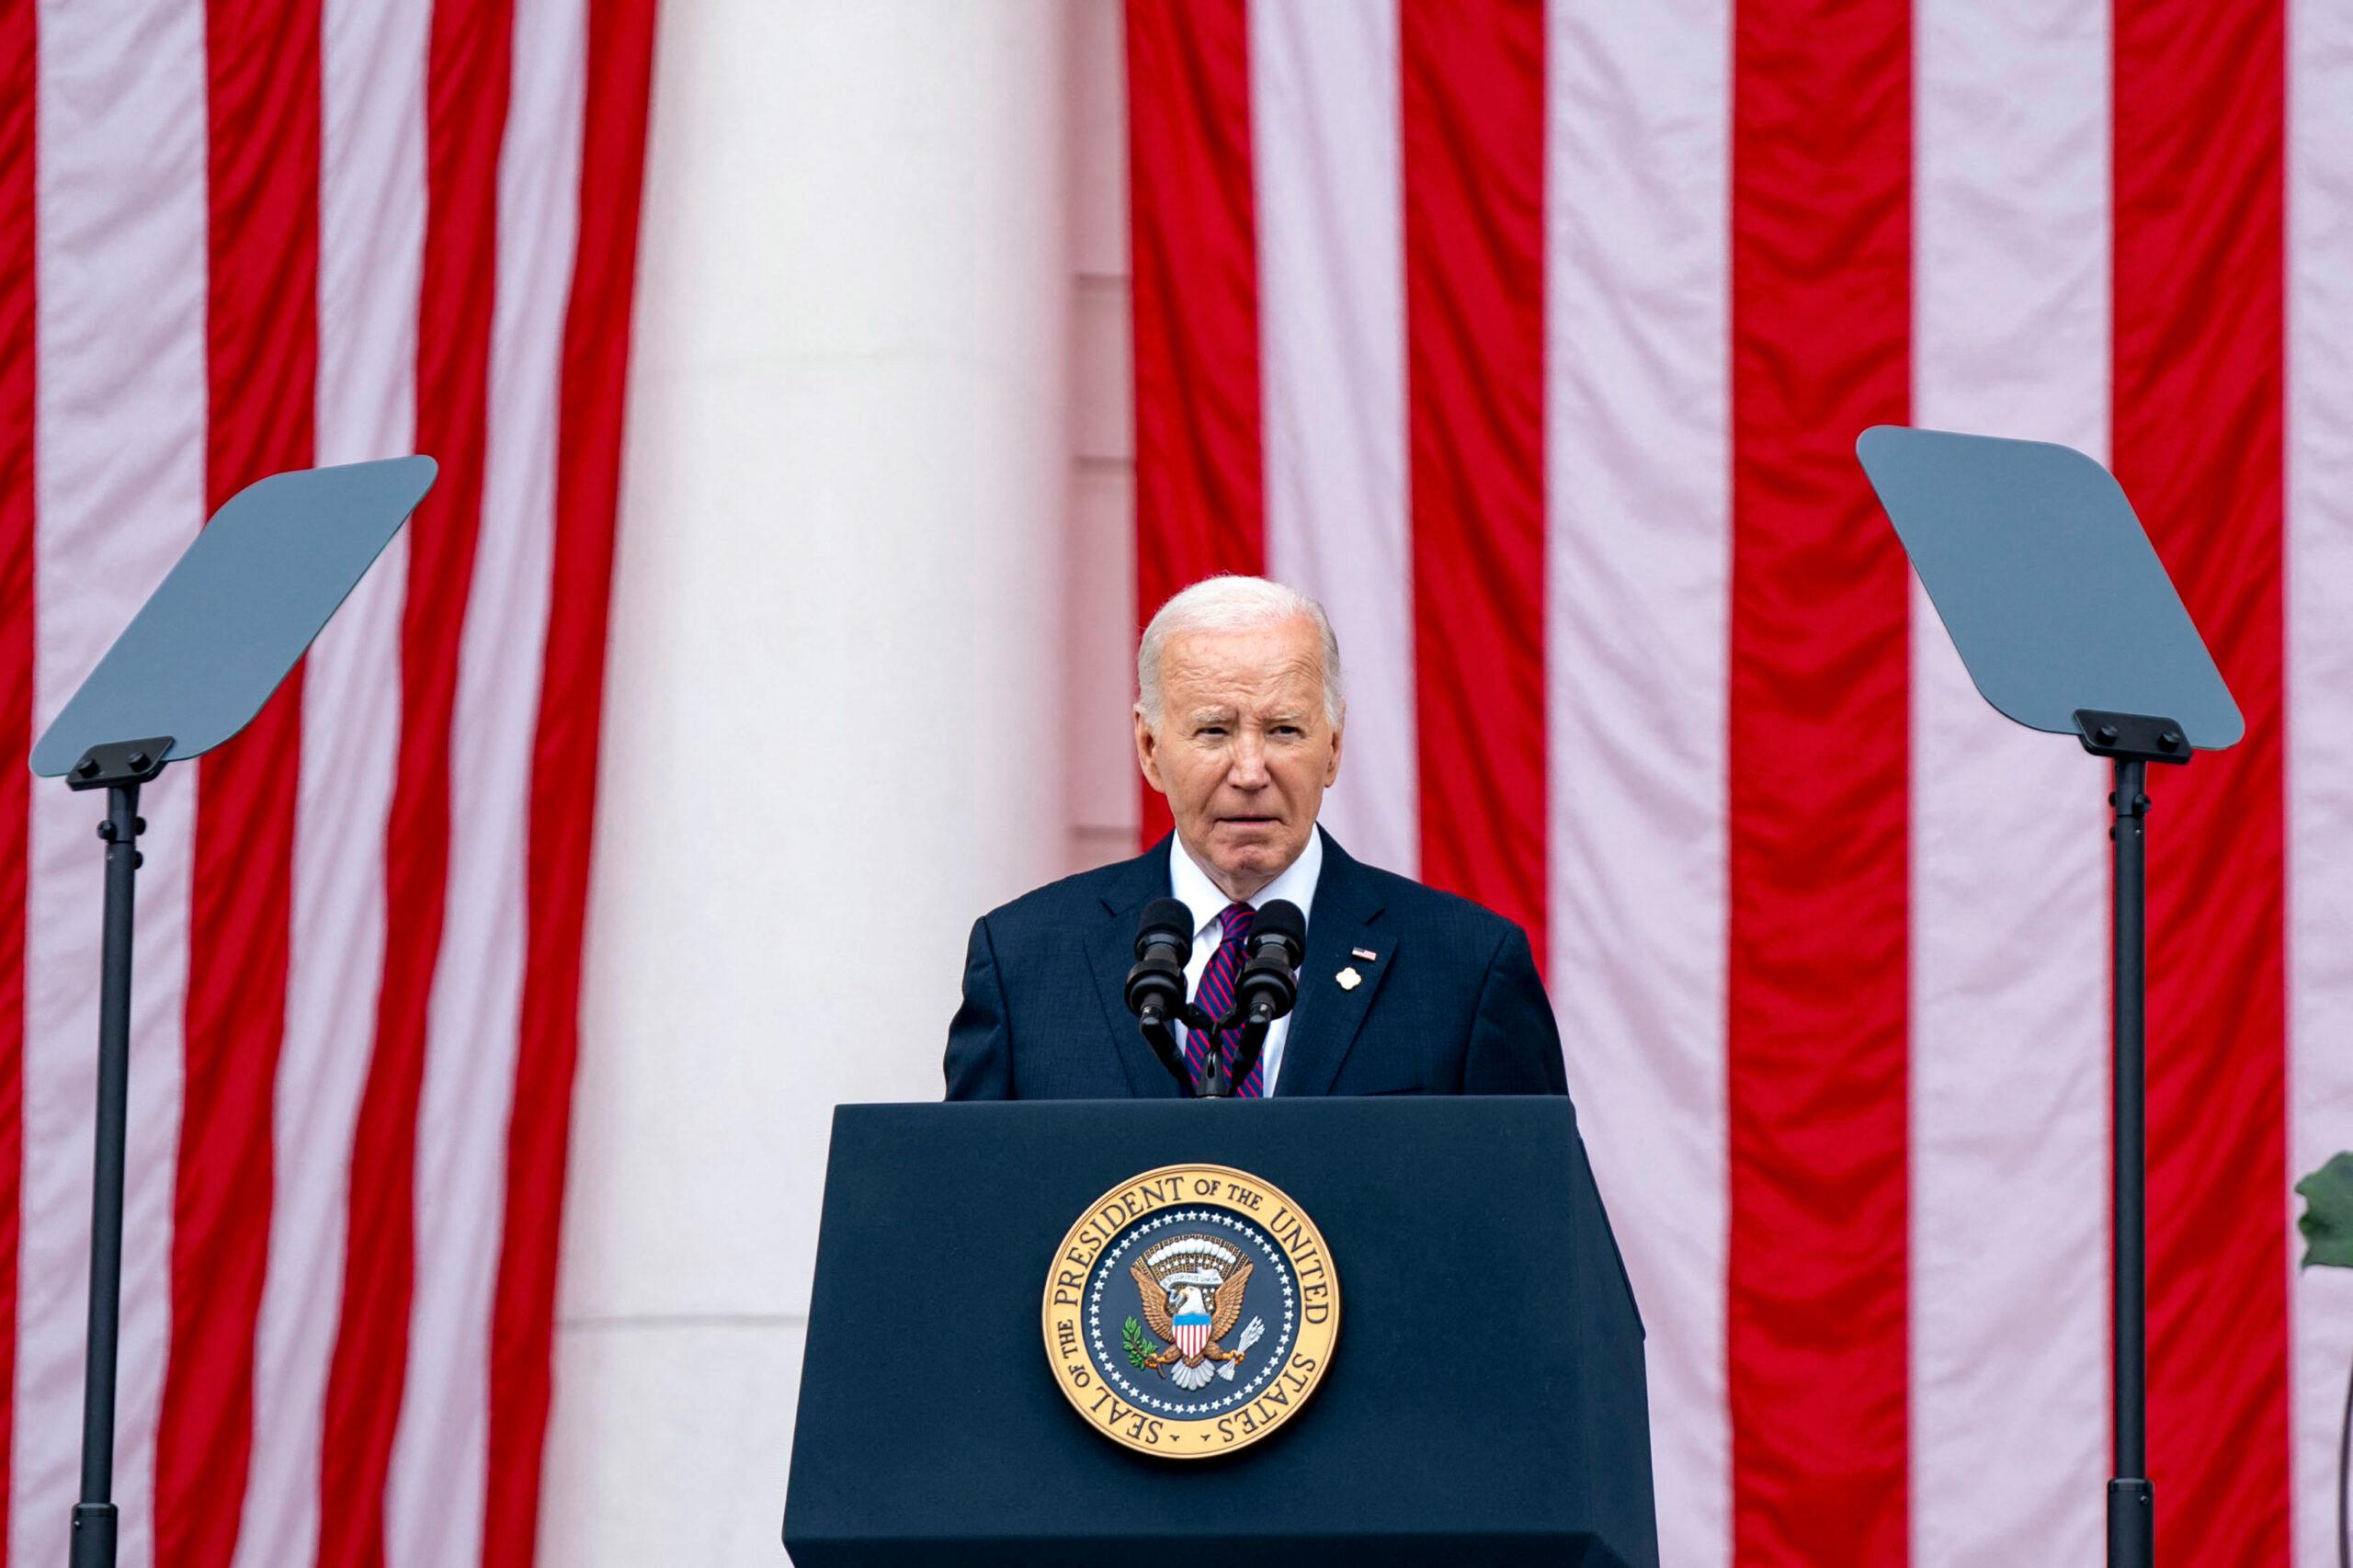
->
155;0;320;1568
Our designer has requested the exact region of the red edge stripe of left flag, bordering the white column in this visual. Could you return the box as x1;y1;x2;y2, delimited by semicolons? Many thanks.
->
483;0;654;1568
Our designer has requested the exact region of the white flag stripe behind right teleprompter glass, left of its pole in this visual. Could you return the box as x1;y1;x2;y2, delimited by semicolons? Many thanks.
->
1911;0;2109;1563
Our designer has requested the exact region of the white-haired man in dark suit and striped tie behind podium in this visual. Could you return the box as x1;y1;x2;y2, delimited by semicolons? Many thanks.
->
946;577;1567;1099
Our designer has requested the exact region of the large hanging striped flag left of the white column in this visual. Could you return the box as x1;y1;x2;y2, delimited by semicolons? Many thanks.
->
0;0;652;1568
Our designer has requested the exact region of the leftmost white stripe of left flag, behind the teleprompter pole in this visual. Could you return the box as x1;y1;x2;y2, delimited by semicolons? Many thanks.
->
9;0;207;1563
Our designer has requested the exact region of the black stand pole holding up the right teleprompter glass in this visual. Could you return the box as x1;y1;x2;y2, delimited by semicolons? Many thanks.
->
2075;709;2190;1568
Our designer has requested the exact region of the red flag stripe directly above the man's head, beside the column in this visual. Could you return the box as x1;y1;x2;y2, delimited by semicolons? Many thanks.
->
1127;0;1266;843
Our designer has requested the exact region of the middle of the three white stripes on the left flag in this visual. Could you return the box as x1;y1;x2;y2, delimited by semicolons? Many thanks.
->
235;0;430;1568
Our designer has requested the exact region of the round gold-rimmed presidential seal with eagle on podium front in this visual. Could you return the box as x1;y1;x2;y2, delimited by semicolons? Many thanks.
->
1045;1165;1339;1460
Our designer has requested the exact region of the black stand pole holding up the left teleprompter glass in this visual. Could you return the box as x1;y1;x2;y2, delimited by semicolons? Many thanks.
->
66;737;172;1568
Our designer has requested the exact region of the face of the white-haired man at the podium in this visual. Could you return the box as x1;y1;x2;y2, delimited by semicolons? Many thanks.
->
1136;615;1339;900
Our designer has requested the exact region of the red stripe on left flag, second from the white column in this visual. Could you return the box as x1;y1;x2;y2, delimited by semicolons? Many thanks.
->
318;0;513;1568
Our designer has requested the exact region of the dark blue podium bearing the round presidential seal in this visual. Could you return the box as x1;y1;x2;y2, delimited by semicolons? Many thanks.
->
783;1095;1659;1568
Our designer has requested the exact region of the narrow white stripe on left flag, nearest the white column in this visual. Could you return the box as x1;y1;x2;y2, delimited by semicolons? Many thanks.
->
383;0;588;1568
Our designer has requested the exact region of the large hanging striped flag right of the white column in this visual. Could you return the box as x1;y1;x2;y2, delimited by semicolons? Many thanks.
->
1127;0;2353;1565
